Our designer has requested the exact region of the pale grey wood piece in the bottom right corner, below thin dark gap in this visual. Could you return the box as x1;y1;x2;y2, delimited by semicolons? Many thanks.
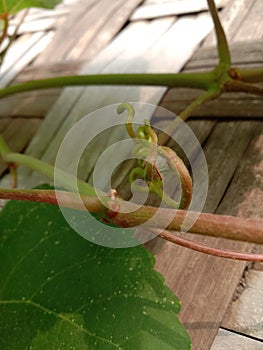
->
211;329;262;350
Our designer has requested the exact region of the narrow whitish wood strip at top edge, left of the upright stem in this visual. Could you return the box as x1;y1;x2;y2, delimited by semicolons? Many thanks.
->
131;0;228;21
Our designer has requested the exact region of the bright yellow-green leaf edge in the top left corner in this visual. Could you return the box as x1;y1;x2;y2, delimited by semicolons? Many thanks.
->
0;0;62;13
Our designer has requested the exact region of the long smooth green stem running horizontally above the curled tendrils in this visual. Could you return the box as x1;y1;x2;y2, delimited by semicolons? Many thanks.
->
0;72;214;99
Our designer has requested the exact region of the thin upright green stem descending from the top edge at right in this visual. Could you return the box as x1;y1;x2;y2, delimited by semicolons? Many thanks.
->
207;0;231;68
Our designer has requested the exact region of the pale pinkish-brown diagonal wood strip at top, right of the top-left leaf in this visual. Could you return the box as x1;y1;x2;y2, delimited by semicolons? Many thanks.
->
38;0;144;63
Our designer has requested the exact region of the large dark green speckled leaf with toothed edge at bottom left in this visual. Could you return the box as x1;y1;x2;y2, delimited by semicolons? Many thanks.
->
0;197;190;350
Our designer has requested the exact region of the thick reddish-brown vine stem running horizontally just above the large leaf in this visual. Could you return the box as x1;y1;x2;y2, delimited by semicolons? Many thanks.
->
0;188;263;244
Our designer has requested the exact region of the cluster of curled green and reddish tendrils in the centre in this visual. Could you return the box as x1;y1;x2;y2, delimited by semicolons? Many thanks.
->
117;102;193;209
